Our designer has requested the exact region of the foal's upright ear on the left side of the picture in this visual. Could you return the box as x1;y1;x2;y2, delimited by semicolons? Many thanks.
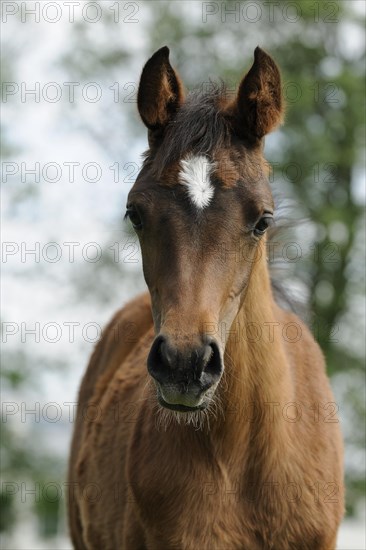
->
137;46;184;143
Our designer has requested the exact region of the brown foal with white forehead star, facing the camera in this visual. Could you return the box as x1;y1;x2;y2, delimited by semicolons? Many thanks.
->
69;47;343;550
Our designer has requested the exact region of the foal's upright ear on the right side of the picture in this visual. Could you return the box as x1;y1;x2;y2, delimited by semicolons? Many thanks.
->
231;47;283;141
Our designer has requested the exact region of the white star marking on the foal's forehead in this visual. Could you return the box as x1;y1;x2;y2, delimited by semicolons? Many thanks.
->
179;155;215;209
